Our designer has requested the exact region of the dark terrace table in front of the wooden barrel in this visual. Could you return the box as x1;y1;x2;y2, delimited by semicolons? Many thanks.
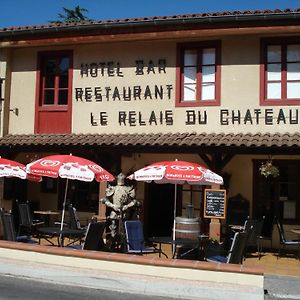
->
149;234;208;260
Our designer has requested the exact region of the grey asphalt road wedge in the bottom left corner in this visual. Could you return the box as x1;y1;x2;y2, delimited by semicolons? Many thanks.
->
0;275;178;300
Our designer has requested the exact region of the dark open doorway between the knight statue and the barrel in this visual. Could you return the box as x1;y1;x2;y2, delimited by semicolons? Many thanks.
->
144;183;175;237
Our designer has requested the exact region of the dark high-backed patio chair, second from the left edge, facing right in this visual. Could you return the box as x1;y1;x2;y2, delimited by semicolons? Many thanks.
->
16;201;45;236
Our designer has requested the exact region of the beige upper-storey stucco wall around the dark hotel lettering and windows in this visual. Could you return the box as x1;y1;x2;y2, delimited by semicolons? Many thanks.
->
9;36;299;133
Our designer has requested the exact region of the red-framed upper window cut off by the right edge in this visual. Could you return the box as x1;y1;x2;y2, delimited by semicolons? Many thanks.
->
261;39;300;105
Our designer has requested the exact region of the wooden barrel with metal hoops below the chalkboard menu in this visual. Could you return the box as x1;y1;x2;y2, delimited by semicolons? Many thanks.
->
175;217;200;240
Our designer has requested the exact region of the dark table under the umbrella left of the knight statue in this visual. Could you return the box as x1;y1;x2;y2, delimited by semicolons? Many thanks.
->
38;227;85;247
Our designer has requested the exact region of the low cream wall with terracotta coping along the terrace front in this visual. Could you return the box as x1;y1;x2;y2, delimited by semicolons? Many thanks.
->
0;241;264;299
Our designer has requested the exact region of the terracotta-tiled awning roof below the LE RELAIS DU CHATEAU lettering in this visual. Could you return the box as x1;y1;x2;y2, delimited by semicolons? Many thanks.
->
0;133;300;148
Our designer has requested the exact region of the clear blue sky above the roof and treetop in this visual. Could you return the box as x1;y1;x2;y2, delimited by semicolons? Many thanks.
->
0;0;300;27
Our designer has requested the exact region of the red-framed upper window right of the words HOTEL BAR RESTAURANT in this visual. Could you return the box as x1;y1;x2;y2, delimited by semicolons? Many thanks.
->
176;42;220;106
